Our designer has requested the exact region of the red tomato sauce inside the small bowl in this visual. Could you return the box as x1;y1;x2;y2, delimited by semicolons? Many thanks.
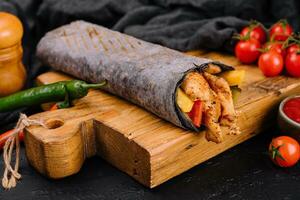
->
283;97;300;123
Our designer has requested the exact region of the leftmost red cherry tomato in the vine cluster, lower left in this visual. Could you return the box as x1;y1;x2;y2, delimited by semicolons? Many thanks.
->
235;39;261;64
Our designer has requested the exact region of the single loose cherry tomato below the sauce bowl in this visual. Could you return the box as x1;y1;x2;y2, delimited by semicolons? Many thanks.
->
269;136;300;167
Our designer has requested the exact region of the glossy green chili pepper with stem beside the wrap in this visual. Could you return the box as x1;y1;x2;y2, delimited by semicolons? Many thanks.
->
0;80;106;112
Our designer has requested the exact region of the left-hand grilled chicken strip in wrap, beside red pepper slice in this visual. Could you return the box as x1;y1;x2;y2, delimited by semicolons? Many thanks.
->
181;72;223;143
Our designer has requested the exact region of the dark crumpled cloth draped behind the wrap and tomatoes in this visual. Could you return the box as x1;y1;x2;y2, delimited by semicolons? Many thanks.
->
0;0;300;127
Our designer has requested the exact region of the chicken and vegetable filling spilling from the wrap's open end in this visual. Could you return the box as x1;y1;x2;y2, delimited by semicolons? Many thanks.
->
176;68;245;143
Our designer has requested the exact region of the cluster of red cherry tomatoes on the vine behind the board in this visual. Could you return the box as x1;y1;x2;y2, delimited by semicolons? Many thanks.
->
235;20;300;77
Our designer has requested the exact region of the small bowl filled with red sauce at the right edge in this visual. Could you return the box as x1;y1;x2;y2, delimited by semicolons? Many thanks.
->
278;95;300;141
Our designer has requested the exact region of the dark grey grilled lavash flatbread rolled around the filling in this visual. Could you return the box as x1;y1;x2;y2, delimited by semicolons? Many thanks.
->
37;21;233;131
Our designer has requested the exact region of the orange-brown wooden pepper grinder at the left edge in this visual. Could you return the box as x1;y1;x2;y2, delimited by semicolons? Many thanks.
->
0;12;26;97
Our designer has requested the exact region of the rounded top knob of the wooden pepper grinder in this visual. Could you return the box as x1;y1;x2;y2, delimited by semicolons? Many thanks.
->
0;12;23;49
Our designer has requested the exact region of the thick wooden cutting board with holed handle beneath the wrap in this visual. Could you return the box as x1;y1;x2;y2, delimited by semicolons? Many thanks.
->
25;51;300;188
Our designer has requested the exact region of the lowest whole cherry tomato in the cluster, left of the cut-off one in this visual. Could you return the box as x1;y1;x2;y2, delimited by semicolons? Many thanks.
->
258;51;283;77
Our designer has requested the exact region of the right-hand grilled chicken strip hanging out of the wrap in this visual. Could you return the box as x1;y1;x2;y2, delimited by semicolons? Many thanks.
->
203;72;238;134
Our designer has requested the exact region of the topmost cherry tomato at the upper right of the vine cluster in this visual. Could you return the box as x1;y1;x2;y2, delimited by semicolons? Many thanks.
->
270;20;293;41
